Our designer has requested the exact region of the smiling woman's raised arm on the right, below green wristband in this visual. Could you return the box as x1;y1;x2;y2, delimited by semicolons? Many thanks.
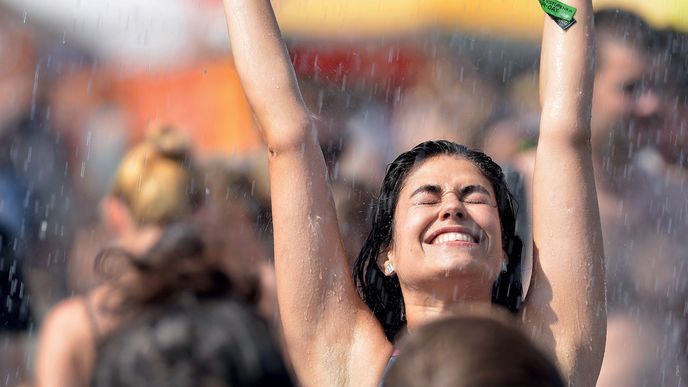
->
524;0;606;386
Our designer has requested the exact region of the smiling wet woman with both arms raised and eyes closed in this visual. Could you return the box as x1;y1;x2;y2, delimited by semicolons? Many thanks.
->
224;0;606;386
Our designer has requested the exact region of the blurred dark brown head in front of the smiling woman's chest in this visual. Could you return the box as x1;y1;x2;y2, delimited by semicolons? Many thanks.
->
384;314;564;387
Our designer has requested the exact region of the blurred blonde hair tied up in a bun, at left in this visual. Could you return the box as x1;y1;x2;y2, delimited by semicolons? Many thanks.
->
110;126;202;225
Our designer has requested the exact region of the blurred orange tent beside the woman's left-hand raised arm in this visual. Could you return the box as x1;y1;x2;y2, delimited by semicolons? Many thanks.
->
113;58;263;155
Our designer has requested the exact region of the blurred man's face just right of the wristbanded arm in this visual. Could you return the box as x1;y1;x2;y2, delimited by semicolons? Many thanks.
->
591;40;647;154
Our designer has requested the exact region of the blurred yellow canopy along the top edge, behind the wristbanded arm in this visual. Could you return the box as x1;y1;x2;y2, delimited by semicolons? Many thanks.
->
275;0;688;40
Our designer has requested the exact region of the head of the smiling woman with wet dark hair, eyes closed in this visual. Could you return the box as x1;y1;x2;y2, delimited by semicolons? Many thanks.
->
354;141;522;340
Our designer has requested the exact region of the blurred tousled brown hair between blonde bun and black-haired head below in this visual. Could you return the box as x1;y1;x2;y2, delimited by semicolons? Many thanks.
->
95;221;234;316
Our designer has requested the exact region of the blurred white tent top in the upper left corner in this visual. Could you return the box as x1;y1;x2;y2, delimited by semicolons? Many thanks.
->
0;0;202;68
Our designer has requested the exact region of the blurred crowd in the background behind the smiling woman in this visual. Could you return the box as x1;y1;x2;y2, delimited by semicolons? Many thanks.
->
0;3;688;386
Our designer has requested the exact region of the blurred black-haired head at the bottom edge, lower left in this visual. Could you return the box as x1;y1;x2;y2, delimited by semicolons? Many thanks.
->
92;297;293;387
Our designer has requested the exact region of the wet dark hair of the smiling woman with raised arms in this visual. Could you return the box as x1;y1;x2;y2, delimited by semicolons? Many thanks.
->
353;140;523;341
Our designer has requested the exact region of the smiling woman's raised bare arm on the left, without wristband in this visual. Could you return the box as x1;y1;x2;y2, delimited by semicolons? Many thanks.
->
224;0;391;385
